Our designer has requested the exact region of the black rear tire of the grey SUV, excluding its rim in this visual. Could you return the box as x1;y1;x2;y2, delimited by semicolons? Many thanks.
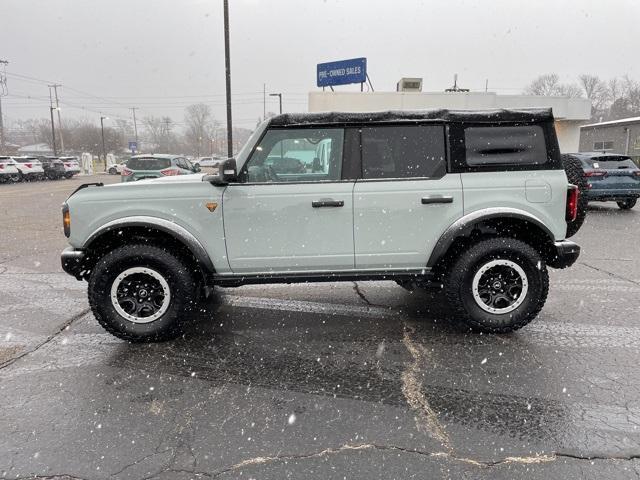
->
444;237;549;333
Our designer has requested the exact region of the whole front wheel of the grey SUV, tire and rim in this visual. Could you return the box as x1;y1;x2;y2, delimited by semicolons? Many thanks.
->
88;245;197;342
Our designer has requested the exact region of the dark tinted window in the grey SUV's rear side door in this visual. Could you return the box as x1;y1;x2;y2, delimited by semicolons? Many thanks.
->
362;125;446;179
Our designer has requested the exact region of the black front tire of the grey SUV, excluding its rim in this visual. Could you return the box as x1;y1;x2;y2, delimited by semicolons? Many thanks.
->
88;244;198;342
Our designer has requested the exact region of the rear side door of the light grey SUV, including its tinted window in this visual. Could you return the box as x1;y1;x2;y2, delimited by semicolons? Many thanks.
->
354;124;463;270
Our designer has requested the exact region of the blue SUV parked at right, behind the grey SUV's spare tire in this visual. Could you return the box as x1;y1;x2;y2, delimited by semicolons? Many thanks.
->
567;152;640;210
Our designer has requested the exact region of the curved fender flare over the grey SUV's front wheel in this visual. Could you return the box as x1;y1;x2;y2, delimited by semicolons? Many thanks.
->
82;215;215;273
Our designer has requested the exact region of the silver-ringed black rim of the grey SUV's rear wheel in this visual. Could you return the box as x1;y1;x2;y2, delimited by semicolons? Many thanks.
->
471;259;529;314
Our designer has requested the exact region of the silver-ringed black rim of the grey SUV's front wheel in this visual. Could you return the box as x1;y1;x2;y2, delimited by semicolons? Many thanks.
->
111;267;171;323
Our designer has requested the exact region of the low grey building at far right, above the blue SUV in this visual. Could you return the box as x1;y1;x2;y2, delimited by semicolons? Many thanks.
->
580;117;640;162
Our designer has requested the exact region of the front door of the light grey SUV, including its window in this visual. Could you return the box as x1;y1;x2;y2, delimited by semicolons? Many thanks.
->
223;128;354;273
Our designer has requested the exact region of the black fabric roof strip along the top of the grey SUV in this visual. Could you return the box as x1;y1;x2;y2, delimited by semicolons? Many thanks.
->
269;108;553;127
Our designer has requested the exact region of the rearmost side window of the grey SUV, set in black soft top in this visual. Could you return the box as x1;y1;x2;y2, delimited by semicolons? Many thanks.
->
464;125;548;166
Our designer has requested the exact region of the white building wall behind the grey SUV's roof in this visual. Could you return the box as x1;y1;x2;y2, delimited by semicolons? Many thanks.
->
309;91;591;152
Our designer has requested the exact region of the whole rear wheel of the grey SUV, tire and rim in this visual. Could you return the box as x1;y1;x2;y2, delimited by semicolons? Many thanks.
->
445;238;549;333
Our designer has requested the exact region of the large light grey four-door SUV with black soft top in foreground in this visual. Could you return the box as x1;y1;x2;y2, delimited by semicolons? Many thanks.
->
62;109;580;342
